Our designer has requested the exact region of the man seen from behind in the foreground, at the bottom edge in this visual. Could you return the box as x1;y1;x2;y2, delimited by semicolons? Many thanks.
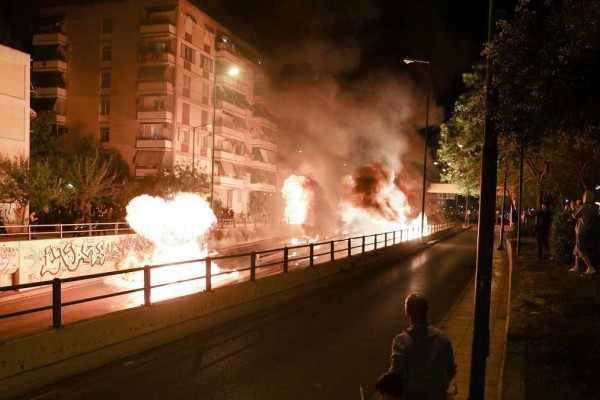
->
390;293;456;400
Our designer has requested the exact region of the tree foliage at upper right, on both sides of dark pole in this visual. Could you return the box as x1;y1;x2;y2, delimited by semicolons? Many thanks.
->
438;0;600;209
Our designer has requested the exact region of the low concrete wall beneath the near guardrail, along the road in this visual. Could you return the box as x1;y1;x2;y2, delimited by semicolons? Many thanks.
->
0;227;461;397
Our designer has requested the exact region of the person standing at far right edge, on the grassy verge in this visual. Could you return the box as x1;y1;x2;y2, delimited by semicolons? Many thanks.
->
569;190;598;275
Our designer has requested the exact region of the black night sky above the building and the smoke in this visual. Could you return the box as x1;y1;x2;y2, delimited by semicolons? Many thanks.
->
0;0;512;114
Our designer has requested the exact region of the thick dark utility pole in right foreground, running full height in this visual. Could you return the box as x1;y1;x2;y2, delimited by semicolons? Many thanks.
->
469;0;498;400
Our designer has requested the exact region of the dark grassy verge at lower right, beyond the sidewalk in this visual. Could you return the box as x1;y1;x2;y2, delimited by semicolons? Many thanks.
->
517;237;600;400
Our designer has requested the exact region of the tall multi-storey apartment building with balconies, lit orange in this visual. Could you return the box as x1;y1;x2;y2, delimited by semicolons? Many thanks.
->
32;0;278;212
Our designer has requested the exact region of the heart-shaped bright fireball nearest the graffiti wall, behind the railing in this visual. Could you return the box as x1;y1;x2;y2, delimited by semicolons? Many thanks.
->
106;193;238;301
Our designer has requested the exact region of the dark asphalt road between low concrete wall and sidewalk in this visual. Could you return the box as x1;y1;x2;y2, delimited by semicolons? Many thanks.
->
19;231;476;400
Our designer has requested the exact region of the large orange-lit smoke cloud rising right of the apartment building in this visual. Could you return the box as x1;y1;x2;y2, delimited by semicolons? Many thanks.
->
198;0;443;231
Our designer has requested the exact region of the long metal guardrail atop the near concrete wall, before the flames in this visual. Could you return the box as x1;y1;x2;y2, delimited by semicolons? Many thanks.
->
0;222;457;329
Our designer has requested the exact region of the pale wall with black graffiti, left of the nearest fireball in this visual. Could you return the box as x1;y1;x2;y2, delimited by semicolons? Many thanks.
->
0;235;154;284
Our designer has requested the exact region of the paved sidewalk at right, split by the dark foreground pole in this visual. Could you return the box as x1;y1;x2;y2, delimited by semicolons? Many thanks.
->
439;239;510;400
